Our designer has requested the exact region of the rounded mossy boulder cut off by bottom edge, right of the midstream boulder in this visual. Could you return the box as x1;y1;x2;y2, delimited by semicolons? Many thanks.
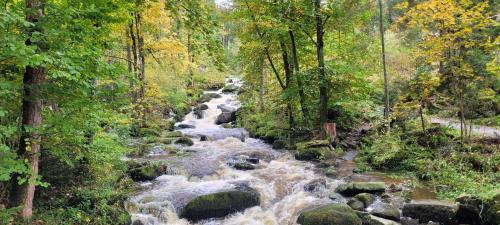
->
297;203;362;225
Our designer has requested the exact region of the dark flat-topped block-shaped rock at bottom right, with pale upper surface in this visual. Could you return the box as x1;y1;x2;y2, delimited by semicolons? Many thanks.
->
403;200;458;225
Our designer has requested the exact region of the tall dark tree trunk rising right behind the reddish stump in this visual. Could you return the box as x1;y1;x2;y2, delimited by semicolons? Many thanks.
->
314;0;328;126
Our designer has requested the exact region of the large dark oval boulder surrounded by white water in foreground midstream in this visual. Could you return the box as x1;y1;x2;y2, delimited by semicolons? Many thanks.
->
180;190;260;222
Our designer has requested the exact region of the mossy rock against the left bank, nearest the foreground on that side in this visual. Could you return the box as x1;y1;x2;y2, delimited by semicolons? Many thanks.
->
128;161;167;181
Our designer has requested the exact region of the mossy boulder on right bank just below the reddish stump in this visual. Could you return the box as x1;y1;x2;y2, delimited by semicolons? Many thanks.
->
295;140;332;161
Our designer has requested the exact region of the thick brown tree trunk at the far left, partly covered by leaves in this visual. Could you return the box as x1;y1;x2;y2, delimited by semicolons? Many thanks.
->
9;0;45;218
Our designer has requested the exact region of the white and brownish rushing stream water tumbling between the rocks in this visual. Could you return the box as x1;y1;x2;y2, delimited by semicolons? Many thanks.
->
127;80;434;225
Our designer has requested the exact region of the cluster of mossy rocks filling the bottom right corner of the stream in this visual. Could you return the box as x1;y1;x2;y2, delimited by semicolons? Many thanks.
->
297;182;500;225
